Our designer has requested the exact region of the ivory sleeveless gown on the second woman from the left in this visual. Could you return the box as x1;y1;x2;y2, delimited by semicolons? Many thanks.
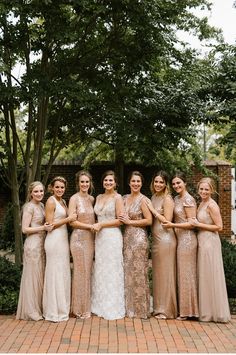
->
43;196;71;322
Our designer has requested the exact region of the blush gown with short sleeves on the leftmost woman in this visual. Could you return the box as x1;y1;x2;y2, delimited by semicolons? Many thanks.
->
16;202;45;321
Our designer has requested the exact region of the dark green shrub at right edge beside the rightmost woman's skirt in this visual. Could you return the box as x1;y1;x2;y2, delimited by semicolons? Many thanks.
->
222;239;236;298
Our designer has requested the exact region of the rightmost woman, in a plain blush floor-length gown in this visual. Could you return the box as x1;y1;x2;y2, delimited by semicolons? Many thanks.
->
191;177;231;323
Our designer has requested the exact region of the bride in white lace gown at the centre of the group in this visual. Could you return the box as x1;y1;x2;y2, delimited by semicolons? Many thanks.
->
91;170;125;320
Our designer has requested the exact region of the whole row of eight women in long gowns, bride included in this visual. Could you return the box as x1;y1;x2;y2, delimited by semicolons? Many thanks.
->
16;170;230;322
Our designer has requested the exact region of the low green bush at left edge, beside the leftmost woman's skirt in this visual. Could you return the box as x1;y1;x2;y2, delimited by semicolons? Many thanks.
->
0;257;21;314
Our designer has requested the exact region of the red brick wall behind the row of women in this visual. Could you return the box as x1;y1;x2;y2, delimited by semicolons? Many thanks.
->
0;161;232;237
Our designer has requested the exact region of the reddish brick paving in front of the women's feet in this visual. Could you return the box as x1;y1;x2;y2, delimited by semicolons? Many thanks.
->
0;316;236;353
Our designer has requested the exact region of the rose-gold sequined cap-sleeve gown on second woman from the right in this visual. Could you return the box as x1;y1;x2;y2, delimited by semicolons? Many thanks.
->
174;192;199;317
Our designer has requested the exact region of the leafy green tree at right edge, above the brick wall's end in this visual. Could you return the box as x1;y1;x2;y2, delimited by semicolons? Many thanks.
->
200;44;236;164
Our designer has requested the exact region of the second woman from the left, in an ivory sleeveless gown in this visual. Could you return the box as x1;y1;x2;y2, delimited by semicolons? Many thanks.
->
43;176;76;322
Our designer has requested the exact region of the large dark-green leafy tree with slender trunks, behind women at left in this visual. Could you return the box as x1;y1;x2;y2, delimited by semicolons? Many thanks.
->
0;0;219;263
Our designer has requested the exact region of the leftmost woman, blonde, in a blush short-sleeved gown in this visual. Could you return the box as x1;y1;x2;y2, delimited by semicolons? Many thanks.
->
16;181;53;321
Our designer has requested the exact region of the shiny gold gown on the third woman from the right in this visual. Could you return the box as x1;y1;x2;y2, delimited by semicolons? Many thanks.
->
151;195;177;318
